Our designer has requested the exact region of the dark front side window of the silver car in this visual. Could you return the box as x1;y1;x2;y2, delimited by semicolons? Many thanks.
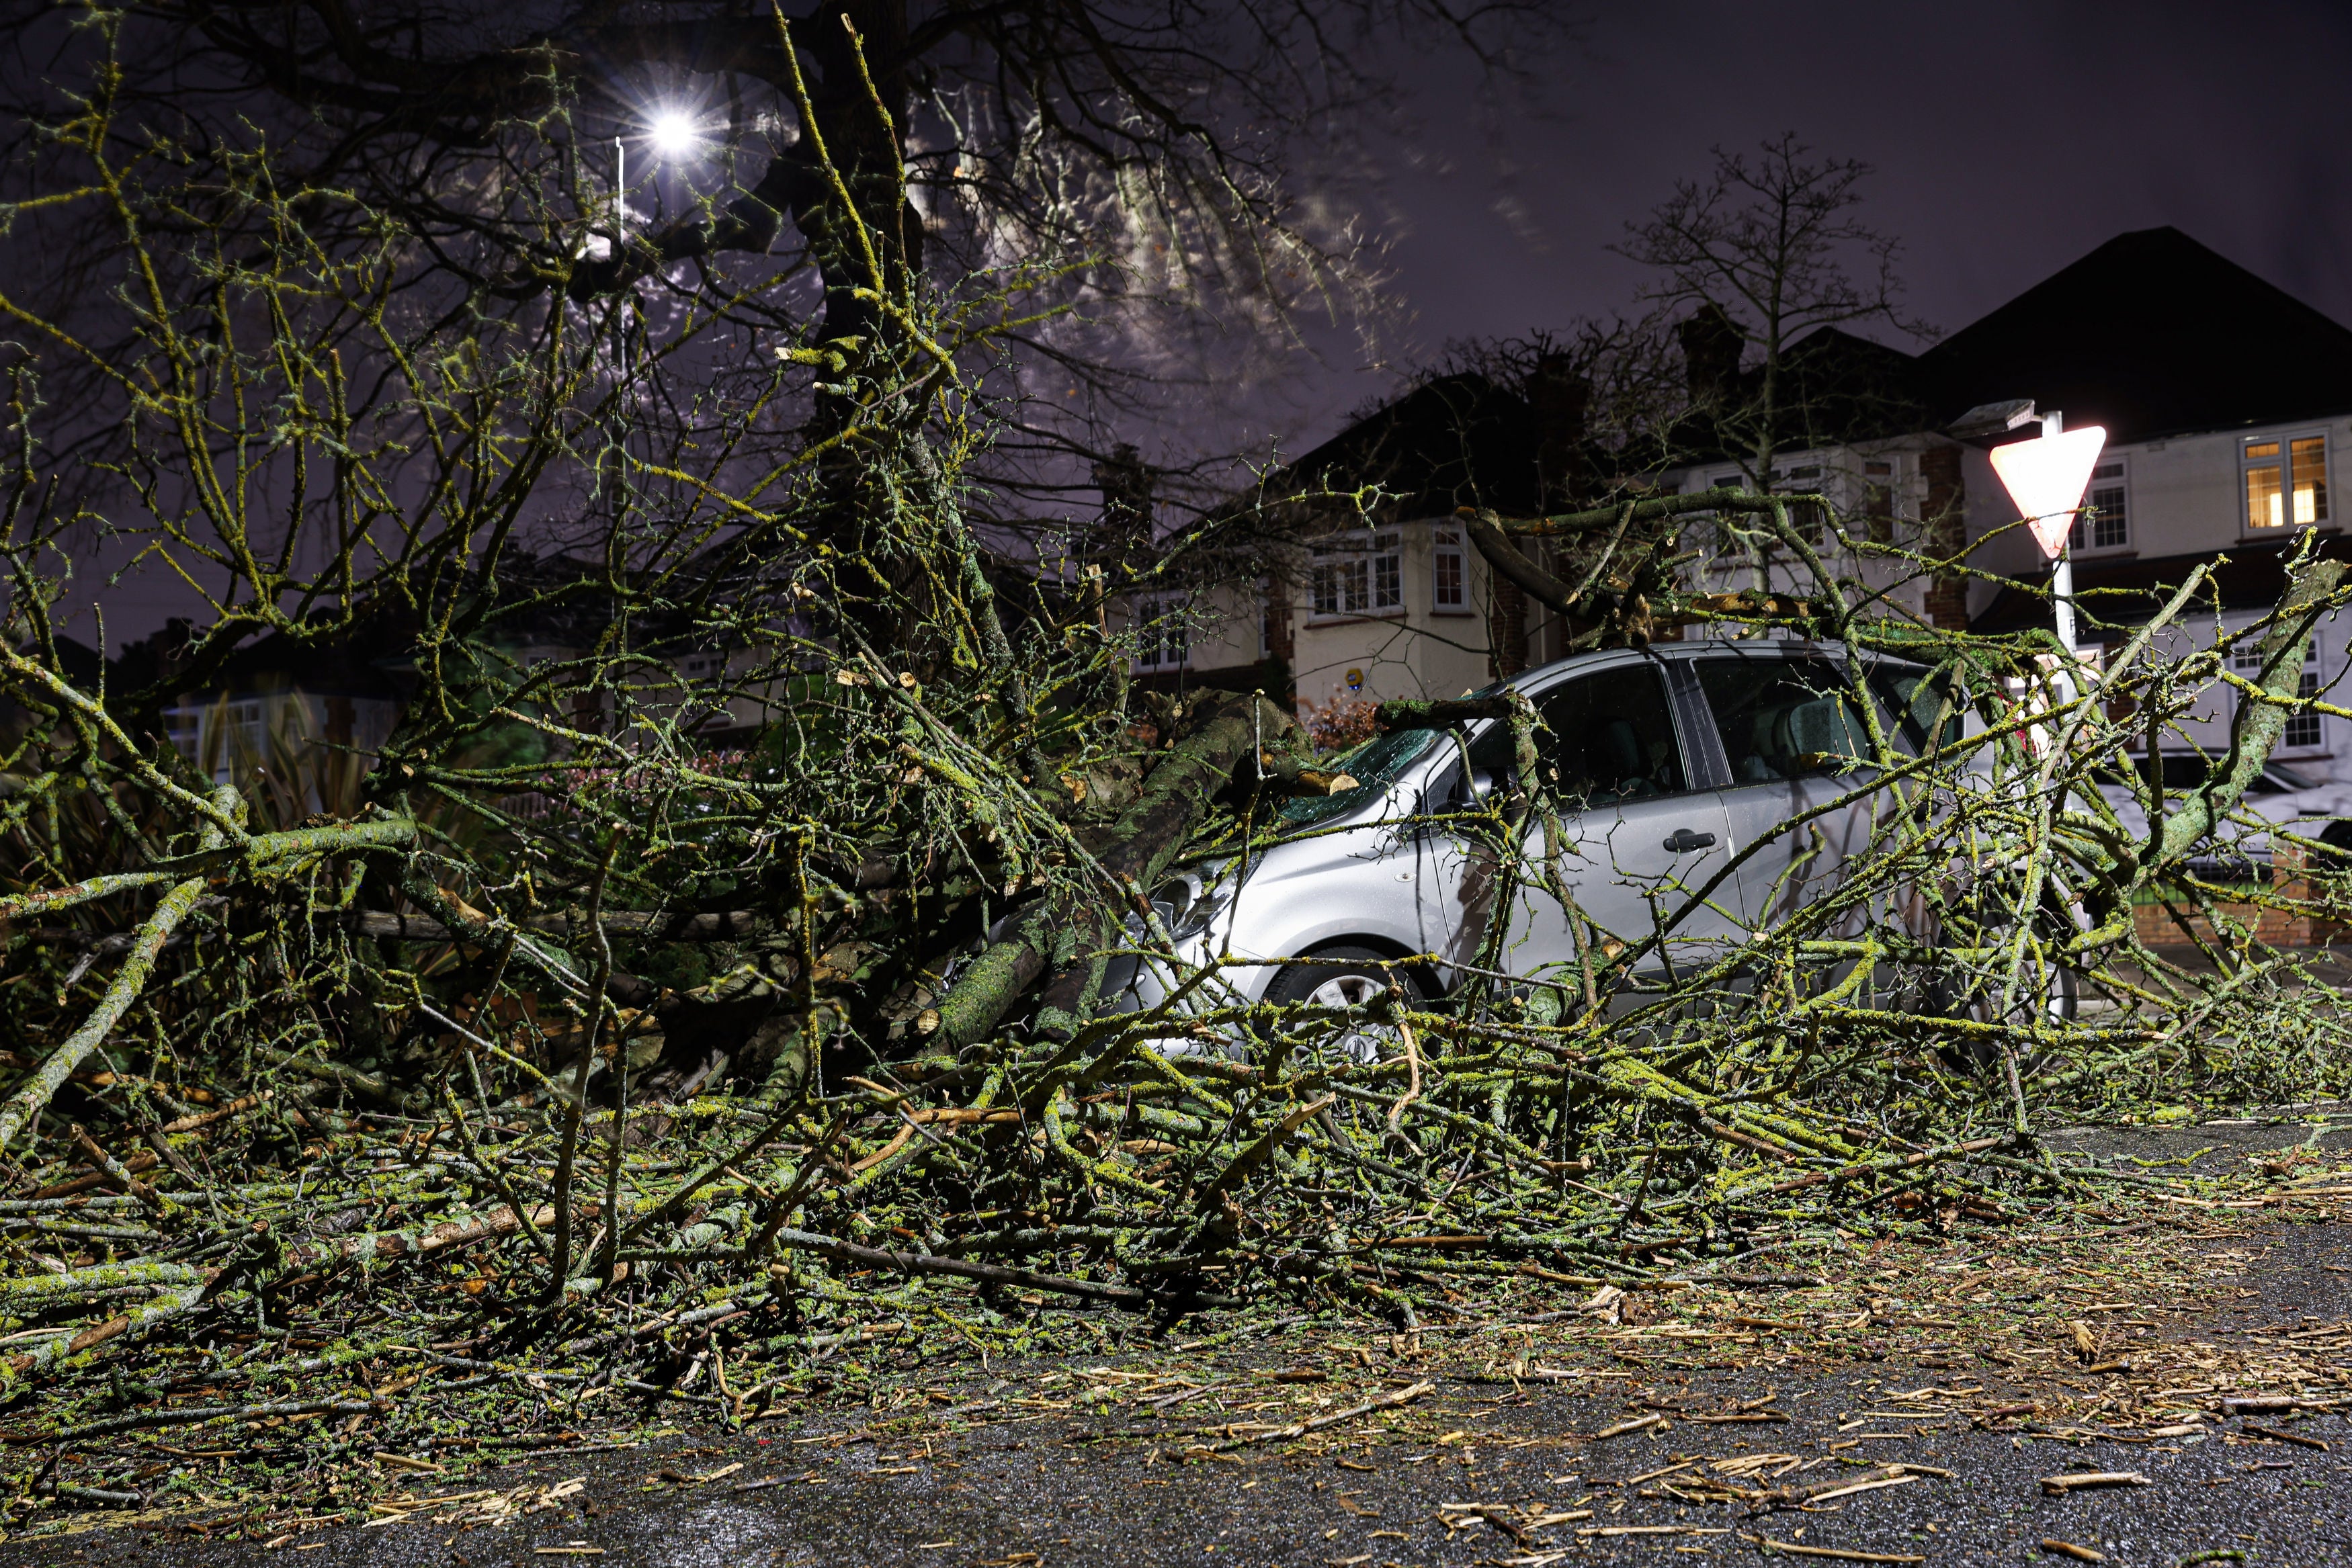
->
1470;665;1691;806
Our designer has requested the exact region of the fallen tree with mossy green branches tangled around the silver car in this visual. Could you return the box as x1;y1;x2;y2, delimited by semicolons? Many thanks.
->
0;12;2347;1532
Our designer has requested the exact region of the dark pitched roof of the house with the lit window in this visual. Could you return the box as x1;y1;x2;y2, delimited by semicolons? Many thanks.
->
1919;228;2352;439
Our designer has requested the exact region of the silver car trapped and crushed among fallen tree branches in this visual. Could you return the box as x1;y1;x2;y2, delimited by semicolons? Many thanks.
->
1122;642;1962;1029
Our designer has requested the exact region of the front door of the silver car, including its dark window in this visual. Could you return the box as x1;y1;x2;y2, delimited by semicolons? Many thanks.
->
1423;656;1740;990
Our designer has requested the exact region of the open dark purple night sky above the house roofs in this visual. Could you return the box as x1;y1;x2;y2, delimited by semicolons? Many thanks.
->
1296;0;2352;425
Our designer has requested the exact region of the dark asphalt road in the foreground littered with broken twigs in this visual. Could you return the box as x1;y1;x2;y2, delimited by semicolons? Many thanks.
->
18;1126;2352;1568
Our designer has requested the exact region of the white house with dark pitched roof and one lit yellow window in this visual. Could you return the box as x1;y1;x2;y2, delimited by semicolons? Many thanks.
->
1922;228;2352;781
